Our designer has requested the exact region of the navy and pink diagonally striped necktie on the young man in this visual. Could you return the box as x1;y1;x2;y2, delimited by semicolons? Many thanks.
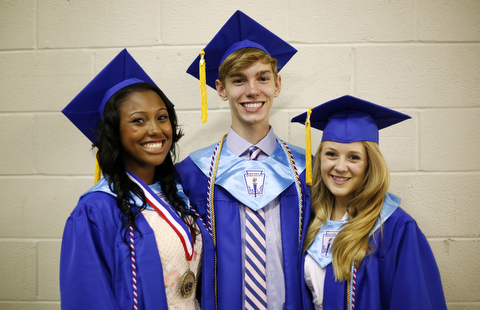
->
245;146;267;310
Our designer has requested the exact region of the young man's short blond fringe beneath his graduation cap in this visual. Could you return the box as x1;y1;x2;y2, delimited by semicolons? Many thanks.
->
218;47;278;85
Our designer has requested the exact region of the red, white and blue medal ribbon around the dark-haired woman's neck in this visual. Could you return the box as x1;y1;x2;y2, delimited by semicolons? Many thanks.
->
125;169;193;260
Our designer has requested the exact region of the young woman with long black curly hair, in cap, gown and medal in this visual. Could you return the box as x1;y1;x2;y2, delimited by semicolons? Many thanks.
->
60;50;206;310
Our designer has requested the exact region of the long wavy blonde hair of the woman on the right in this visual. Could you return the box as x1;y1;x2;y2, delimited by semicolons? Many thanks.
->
304;141;390;281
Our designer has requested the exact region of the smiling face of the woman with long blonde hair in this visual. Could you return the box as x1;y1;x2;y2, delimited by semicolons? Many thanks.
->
320;141;368;206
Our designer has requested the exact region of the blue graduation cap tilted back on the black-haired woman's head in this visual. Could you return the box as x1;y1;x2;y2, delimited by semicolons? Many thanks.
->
62;49;155;143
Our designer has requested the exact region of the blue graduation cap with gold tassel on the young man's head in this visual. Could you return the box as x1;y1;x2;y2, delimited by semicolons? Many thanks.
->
187;11;297;122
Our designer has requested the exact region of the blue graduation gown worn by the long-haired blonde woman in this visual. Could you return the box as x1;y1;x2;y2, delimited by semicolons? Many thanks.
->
304;197;447;310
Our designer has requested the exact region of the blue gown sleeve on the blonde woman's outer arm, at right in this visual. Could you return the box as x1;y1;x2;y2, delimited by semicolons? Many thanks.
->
380;220;447;310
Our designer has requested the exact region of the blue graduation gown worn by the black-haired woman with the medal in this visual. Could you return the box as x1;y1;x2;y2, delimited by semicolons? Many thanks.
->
60;179;208;310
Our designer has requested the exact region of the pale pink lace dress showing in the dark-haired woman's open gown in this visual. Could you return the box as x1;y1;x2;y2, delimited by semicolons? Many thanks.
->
142;210;202;310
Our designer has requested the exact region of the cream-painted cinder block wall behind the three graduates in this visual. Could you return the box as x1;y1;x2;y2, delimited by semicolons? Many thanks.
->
0;0;480;310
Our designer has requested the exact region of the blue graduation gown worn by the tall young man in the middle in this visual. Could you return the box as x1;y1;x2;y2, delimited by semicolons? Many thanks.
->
176;140;310;310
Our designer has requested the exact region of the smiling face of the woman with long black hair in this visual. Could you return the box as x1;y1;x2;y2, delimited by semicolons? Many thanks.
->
118;90;172;184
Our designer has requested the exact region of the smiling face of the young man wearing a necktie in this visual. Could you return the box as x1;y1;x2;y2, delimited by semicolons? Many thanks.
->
216;61;281;136
